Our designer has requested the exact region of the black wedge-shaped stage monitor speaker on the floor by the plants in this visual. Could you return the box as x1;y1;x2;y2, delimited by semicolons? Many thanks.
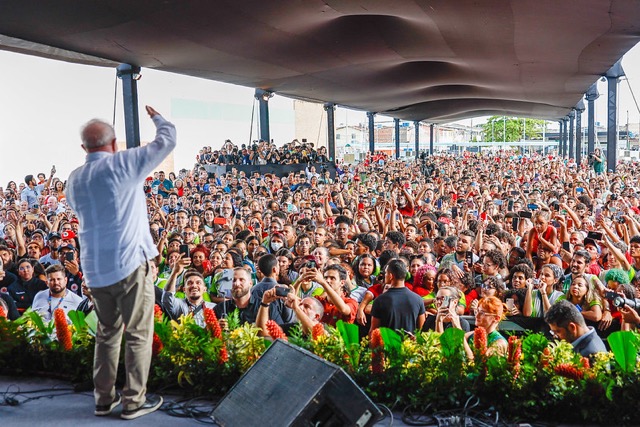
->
213;340;382;427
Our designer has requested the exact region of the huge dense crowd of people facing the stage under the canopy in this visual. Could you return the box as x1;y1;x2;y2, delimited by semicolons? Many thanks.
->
0;141;640;357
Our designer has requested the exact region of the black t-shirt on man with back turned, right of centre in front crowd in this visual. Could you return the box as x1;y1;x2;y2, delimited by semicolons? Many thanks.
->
371;287;425;332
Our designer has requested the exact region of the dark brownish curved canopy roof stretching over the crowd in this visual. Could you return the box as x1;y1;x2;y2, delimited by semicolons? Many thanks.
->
0;0;640;123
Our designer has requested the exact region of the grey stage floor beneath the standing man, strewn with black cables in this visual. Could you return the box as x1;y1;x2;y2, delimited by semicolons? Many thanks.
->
0;376;407;427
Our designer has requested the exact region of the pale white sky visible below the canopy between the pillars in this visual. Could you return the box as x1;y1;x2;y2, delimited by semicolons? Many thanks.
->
0;40;640;188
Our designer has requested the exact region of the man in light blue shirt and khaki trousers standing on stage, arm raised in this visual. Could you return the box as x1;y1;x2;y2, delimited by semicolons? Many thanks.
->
66;106;176;419
